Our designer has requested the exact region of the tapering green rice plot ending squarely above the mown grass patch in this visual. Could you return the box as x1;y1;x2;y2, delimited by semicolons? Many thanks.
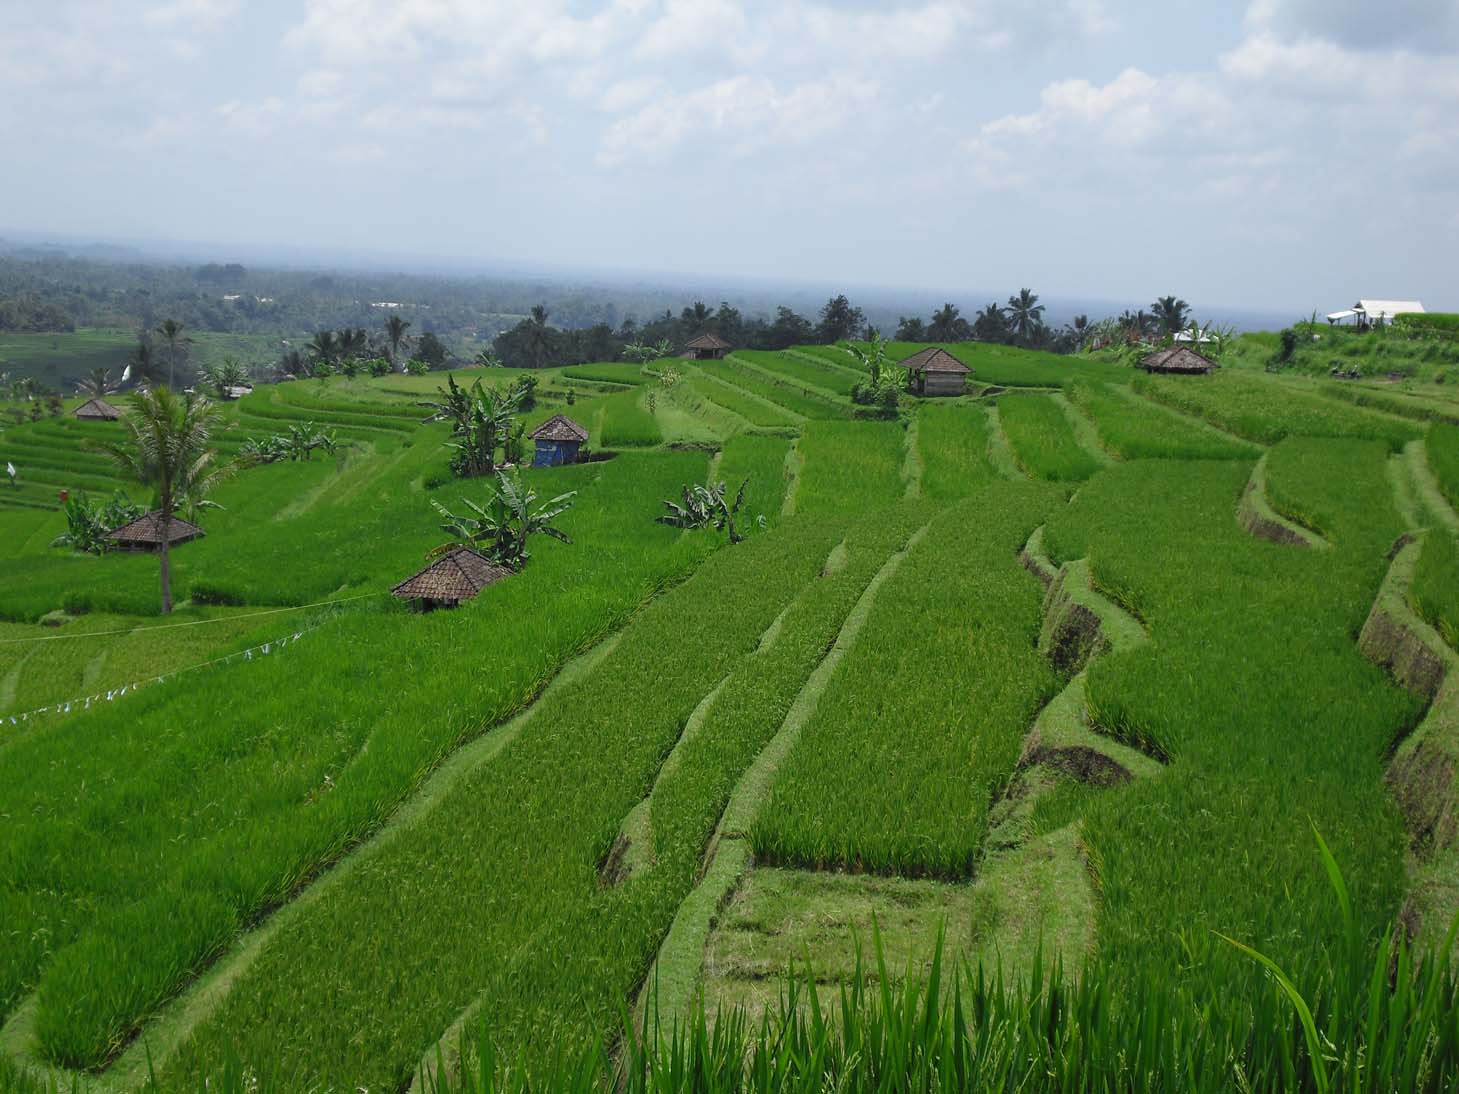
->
751;484;1055;877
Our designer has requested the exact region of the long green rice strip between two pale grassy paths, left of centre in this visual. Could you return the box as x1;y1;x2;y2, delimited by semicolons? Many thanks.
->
159;513;839;1088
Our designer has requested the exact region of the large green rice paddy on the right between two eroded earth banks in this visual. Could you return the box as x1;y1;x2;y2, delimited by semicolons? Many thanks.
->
1046;439;1418;1033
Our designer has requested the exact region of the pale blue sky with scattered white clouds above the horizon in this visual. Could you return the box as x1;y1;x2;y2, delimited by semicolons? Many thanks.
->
0;0;1459;312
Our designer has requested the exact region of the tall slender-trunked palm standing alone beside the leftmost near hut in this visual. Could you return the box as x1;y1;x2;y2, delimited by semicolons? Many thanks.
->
98;388;226;614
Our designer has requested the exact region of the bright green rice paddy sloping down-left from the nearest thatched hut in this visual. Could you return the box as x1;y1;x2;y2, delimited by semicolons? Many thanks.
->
0;454;708;1065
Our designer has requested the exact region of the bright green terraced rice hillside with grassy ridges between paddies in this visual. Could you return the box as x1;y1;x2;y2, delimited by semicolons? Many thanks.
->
0;352;1459;1091
